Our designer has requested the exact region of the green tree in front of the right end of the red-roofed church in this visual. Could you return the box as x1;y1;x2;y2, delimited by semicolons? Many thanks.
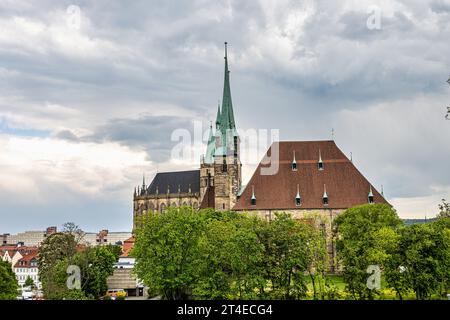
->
334;204;402;299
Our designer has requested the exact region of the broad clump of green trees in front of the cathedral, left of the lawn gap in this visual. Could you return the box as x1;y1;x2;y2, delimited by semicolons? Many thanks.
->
133;207;324;299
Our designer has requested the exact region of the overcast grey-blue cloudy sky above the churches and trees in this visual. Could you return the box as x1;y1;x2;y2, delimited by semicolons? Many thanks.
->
0;0;450;233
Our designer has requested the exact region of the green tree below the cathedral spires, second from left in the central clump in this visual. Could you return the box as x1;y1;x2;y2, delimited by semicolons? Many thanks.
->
193;211;266;299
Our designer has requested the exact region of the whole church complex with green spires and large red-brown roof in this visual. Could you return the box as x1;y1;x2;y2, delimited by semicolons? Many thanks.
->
134;43;387;251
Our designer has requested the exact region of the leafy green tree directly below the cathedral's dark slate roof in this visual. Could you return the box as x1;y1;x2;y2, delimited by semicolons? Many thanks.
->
133;207;206;299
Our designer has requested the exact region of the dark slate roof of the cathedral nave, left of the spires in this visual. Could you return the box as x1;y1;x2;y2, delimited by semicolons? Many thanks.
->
147;170;200;194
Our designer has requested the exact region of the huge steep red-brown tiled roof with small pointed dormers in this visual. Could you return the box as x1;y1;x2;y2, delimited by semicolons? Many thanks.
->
233;141;387;210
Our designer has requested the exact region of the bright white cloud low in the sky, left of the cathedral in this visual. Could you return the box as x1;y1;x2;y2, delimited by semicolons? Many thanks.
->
0;135;151;204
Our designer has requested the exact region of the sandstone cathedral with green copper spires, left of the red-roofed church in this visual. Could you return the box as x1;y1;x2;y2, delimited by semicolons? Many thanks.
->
133;42;242;228
